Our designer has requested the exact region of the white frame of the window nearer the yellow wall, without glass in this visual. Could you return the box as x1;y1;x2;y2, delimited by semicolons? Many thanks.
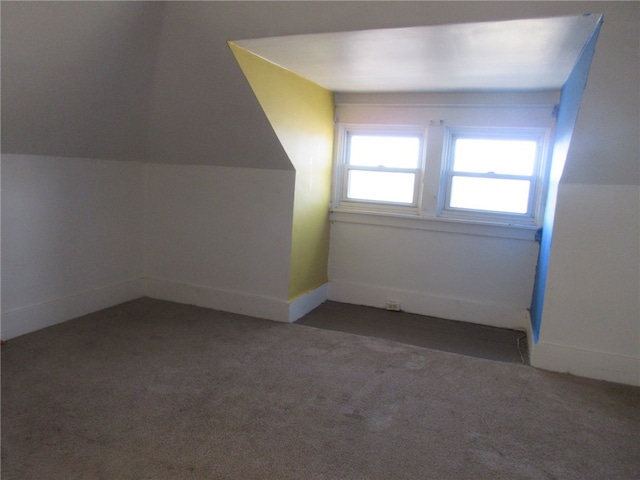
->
333;123;428;215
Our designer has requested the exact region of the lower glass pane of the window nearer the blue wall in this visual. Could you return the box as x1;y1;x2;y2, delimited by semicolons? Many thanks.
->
449;176;531;213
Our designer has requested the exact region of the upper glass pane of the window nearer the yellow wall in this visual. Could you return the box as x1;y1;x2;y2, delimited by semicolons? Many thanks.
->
349;135;420;168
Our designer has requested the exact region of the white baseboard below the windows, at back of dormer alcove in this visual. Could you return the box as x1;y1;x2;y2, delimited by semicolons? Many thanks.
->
328;281;529;330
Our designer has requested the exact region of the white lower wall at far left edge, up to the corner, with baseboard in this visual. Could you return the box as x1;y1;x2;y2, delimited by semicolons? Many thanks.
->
1;154;143;339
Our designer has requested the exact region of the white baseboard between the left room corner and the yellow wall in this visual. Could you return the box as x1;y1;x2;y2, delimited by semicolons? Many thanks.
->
144;278;289;322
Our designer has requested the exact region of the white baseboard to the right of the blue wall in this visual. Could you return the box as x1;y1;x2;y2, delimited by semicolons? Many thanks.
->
529;342;640;386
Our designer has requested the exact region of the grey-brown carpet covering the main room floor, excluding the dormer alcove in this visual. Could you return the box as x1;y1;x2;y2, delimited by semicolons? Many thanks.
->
2;299;640;480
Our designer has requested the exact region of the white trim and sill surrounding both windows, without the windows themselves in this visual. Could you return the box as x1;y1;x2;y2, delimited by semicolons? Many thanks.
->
329;101;557;241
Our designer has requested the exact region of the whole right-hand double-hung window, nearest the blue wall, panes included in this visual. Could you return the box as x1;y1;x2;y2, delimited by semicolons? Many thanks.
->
441;129;544;223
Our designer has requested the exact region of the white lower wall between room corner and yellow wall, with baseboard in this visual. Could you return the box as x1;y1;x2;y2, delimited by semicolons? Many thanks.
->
145;164;295;321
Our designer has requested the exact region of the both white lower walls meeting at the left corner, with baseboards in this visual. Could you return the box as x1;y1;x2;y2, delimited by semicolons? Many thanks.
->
1;159;295;340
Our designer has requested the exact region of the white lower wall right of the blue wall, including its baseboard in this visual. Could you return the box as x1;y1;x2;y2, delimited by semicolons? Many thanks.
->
532;184;640;385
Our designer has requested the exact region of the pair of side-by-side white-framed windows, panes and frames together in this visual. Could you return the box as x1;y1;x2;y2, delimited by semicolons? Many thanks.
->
334;117;550;225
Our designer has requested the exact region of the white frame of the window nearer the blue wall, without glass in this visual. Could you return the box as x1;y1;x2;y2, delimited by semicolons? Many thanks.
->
437;126;551;225
